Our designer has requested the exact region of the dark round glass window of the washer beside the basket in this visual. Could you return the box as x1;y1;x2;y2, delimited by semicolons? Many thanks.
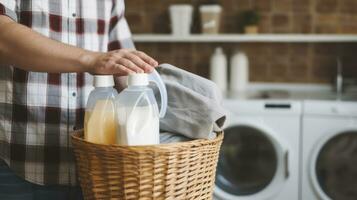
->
216;126;278;196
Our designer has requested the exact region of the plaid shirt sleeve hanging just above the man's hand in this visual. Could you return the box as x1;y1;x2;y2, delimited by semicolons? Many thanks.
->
108;0;135;51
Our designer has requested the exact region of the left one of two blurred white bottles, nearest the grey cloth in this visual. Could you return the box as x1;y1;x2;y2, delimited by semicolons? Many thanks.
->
210;47;227;92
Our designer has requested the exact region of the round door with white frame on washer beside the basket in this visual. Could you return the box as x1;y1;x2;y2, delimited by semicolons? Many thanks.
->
215;119;289;200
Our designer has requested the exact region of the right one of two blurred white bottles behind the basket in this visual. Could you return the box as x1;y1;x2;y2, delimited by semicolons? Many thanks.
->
230;51;249;92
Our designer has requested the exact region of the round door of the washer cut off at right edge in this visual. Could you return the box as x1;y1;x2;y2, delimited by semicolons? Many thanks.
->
310;127;357;200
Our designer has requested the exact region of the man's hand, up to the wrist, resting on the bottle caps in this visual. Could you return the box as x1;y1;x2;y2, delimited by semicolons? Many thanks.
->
82;49;158;76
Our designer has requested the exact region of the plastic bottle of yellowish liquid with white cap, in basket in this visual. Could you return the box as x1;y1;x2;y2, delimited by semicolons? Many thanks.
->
84;75;118;145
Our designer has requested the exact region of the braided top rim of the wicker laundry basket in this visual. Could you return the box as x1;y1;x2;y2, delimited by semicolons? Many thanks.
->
71;129;224;149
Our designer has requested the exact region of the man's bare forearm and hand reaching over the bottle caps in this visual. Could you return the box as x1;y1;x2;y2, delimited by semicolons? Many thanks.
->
0;16;158;76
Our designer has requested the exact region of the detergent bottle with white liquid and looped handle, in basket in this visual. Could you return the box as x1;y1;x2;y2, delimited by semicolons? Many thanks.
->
116;71;167;146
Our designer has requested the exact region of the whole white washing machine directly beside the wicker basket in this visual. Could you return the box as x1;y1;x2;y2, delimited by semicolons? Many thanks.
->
214;99;302;200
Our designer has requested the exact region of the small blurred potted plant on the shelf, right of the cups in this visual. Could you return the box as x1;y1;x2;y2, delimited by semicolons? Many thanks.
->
242;10;260;34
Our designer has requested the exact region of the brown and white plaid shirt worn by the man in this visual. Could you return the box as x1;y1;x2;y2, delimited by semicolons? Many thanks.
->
0;0;132;185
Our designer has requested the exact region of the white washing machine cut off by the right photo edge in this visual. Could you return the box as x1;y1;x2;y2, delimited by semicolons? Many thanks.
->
301;100;357;200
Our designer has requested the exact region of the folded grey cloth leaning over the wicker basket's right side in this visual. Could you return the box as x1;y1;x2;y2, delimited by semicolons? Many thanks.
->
155;64;226;140
